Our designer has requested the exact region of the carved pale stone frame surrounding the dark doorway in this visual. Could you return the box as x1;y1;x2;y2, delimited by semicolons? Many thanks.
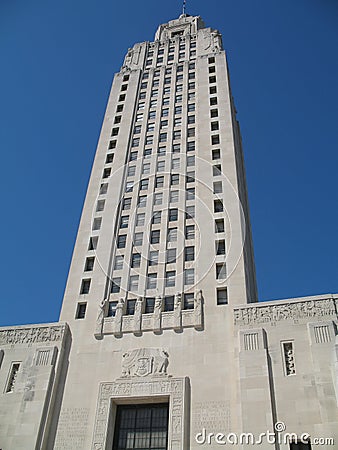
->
92;377;188;450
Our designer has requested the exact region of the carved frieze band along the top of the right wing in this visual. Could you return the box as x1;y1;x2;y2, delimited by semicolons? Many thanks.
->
234;298;337;325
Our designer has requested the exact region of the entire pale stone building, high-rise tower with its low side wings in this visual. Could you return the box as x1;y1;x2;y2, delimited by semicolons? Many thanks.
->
0;15;338;450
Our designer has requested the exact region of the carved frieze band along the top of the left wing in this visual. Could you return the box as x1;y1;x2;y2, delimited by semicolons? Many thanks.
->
0;325;66;345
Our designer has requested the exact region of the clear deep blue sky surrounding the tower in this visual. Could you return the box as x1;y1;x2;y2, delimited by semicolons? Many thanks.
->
0;0;338;325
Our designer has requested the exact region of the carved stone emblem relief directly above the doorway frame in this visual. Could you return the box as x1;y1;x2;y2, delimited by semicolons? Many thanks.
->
122;348;169;378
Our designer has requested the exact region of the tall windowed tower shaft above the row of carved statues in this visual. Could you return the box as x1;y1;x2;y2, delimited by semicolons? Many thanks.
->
61;15;256;328
